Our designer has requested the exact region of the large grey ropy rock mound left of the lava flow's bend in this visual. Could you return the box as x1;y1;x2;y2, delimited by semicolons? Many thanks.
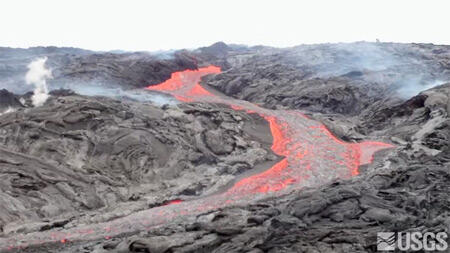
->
0;91;277;239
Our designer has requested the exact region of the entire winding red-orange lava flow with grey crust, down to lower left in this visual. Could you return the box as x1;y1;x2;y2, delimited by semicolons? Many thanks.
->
0;66;393;249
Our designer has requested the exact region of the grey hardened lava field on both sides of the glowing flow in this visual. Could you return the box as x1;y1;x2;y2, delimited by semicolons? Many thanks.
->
0;43;450;253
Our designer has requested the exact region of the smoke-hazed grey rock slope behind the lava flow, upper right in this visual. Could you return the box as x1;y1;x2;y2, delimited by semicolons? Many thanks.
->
203;42;450;115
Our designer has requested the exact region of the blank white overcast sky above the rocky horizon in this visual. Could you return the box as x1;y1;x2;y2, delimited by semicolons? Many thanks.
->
0;0;450;51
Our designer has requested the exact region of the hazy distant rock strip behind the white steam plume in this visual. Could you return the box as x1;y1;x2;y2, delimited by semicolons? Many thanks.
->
0;47;197;94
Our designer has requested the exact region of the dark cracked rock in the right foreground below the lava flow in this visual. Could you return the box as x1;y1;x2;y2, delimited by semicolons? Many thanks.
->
51;85;450;252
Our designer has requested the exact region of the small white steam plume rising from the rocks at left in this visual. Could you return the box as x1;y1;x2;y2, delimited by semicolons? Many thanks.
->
25;57;52;106
